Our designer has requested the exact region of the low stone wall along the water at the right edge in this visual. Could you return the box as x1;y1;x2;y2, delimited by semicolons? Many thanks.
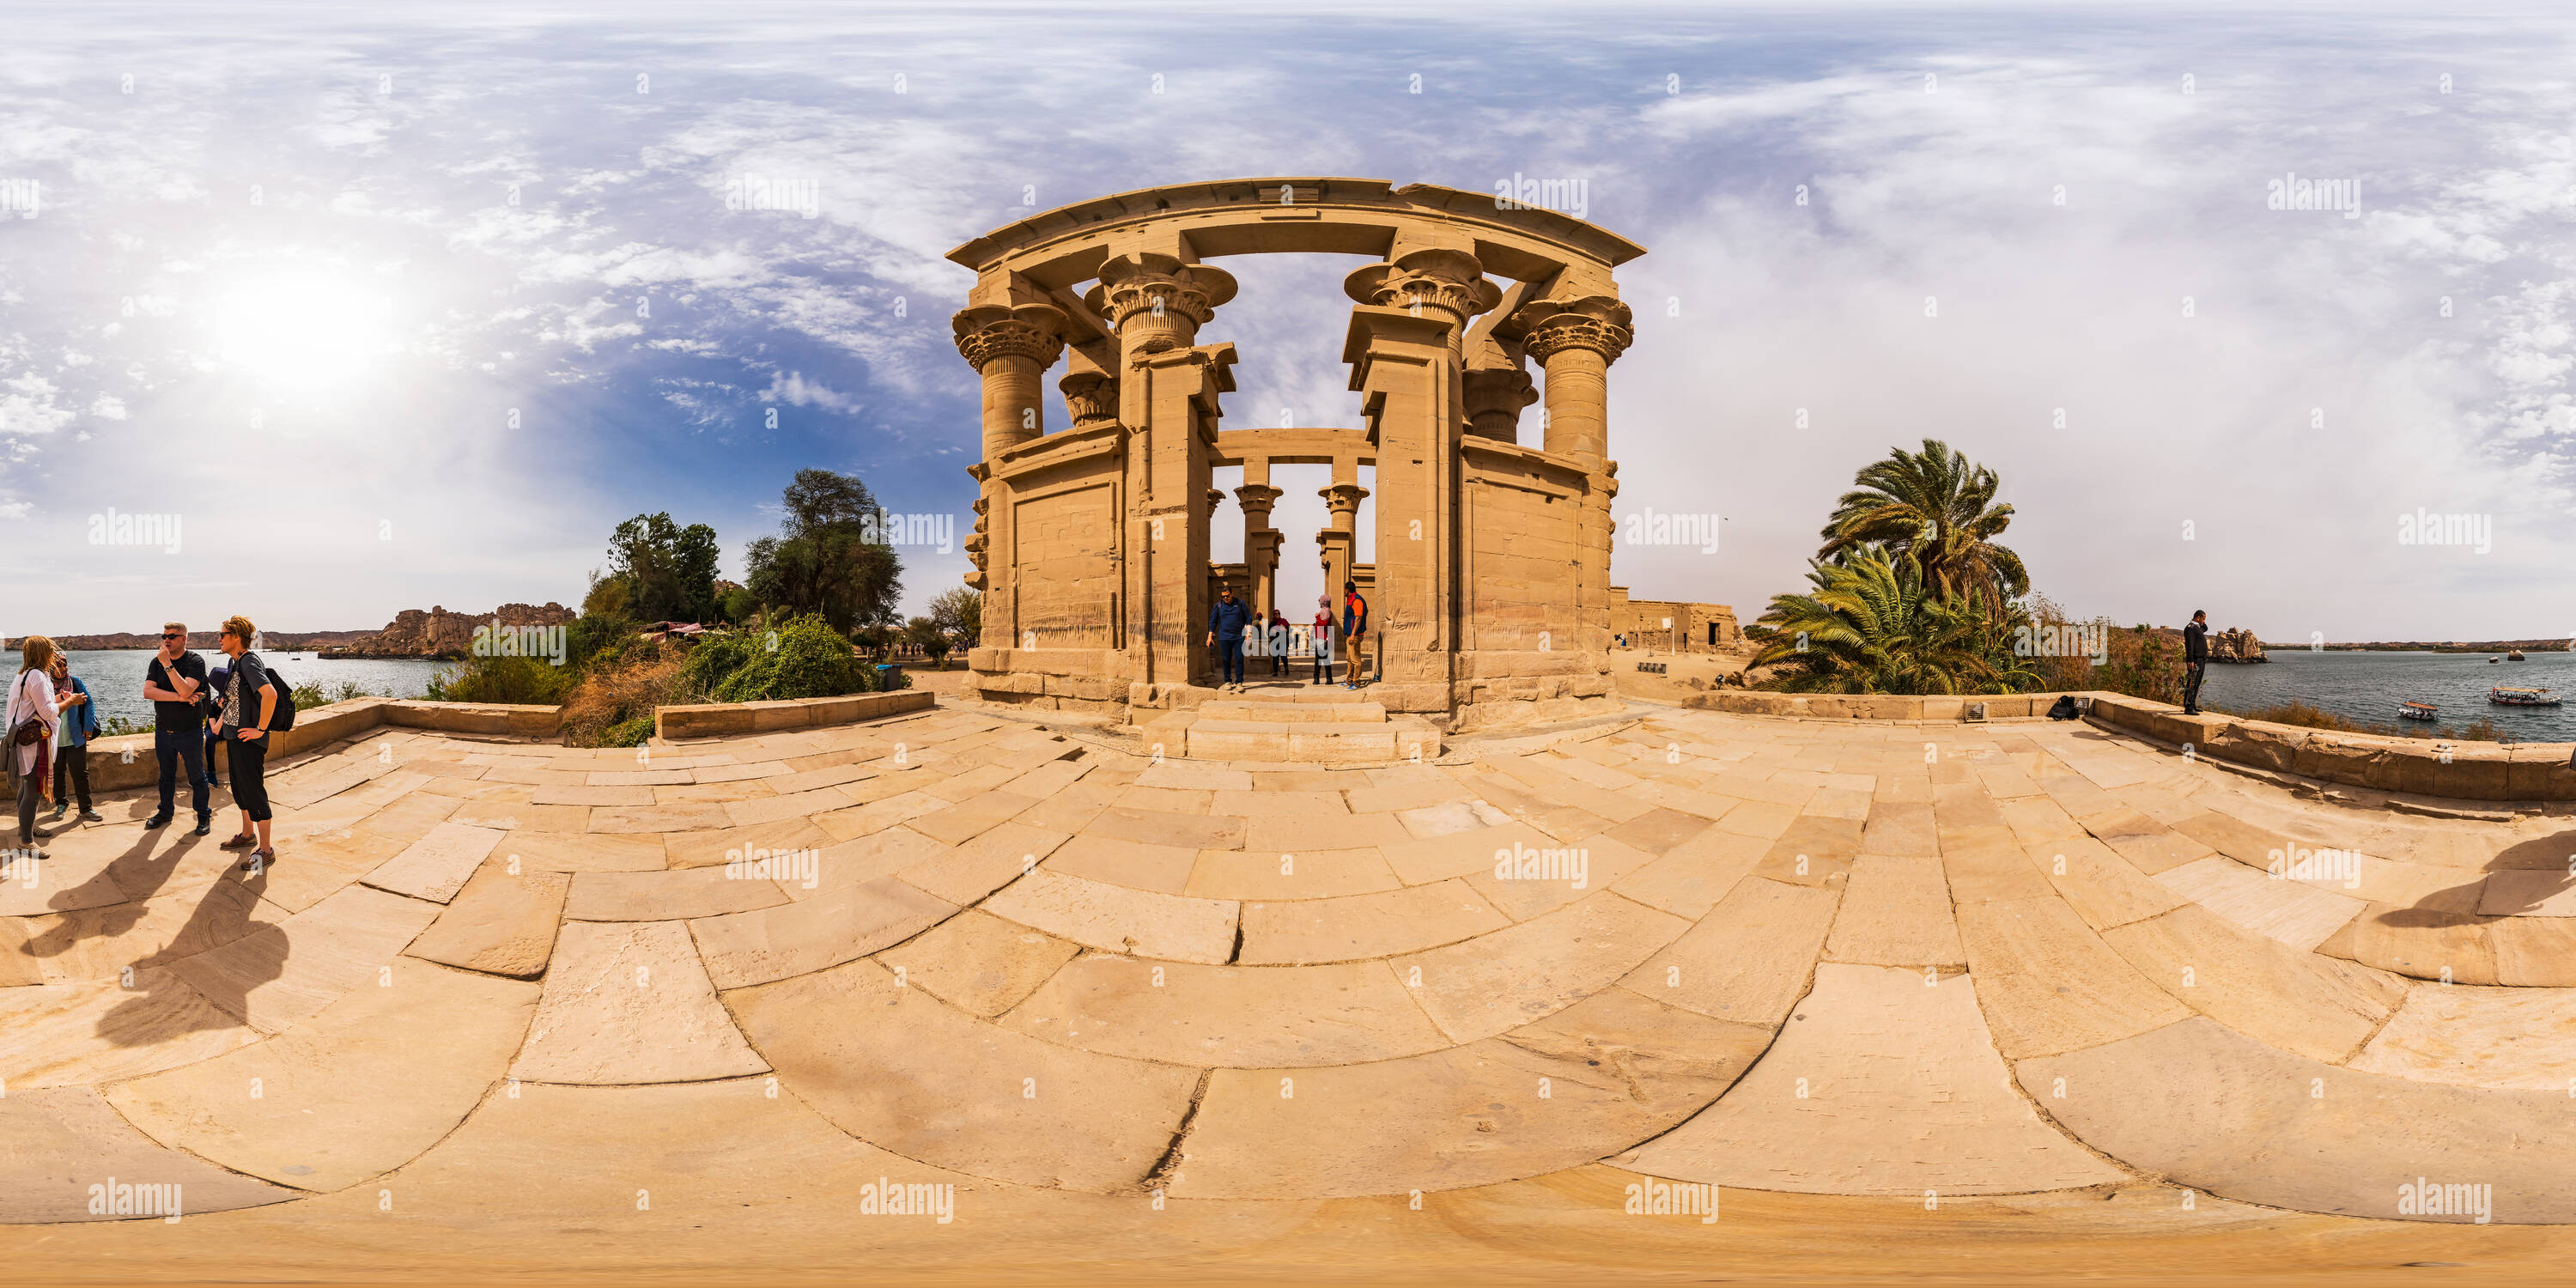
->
2092;693;2576;801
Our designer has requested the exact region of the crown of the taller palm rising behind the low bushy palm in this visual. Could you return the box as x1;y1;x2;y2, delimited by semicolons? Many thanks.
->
1816;438;2030;618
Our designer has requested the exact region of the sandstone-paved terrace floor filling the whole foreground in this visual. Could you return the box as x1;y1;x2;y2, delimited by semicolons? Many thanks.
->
0;706;2576;1280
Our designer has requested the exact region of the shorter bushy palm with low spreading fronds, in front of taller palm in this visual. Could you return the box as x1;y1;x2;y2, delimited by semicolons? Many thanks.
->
1752;546;2040;693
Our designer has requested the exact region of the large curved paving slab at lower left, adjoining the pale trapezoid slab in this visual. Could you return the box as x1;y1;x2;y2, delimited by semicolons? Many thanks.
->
108;961;538;1190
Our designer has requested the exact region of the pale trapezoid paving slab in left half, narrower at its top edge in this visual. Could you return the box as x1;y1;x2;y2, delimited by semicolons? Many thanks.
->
510;922;768;1084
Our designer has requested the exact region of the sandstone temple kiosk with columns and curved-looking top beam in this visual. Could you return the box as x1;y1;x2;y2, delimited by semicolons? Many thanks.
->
948;178;1643;732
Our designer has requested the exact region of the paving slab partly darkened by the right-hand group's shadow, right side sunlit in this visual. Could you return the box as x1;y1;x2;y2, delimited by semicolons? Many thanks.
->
170;886;438;1033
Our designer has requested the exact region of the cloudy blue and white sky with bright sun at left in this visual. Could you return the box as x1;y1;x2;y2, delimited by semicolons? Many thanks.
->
0;3;2576;641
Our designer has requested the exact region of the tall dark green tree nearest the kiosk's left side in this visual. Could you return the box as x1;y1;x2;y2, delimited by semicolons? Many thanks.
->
744;469;904;631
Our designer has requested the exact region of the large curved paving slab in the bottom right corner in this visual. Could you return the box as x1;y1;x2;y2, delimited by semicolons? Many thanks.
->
2014;1015;2576;1224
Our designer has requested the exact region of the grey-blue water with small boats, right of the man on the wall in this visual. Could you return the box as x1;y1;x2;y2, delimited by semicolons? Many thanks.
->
2200;649;2576;742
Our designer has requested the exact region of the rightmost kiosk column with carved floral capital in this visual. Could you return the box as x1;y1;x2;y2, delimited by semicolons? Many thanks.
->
1520;296;1633;665
